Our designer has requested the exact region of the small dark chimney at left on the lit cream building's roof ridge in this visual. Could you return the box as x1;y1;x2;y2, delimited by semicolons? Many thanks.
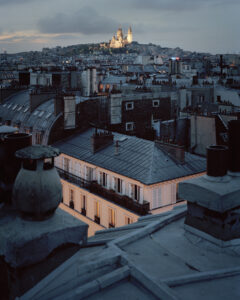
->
91;128;113;154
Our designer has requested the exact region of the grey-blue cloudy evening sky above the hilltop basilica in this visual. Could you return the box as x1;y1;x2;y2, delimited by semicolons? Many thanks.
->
0;0;240;53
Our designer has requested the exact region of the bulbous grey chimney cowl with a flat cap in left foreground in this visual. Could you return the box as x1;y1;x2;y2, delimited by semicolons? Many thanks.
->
12;145;62;221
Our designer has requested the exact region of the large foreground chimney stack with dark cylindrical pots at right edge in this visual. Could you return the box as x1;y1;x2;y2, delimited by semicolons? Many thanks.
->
179;120;240;247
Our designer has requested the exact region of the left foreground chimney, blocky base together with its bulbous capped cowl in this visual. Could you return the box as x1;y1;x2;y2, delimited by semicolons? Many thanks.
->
0;145;88;299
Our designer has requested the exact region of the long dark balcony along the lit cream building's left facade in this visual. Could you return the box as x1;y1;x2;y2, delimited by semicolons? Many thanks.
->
56;168;150;216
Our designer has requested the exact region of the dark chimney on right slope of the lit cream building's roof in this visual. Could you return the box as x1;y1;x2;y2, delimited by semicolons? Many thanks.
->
155;140;185;164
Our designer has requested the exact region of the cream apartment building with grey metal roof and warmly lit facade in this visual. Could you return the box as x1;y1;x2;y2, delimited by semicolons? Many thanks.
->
54;129;206;233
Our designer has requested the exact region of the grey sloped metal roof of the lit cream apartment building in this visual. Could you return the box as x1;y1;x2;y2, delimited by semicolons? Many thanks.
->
53;129;206;185
